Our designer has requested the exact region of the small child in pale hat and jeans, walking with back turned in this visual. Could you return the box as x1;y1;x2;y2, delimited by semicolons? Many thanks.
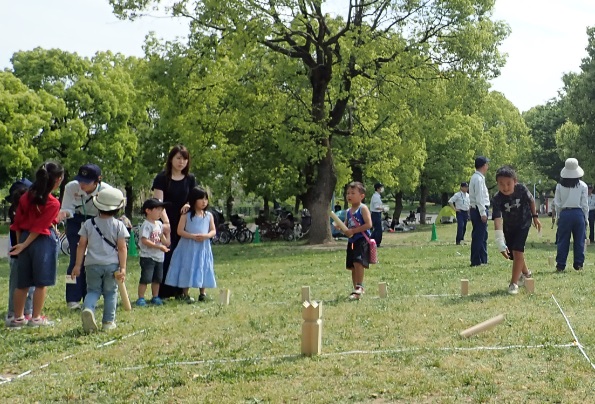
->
71;188;130;333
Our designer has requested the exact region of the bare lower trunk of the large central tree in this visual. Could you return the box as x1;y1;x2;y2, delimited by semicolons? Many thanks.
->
304;147;337;244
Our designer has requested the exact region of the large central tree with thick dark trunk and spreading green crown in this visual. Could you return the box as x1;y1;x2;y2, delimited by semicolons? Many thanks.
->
110;0;507;243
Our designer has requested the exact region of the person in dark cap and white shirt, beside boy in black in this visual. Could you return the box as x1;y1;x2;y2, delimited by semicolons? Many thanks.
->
469;156;490;267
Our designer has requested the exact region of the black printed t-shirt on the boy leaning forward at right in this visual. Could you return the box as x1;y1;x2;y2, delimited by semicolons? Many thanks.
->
492;184;533;231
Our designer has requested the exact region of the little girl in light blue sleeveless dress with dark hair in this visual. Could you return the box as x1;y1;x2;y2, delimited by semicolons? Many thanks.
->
165;187;217;303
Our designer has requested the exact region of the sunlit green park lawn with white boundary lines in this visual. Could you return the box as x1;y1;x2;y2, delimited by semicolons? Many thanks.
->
0;223;595;403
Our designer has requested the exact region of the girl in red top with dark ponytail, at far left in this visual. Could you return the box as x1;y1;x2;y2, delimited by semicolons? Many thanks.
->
9;162;64;327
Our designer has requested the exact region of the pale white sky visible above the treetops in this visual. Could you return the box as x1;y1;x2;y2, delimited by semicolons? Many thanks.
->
0;0;595;111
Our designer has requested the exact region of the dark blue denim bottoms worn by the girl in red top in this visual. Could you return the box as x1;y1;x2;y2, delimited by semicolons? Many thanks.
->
16;229;58;289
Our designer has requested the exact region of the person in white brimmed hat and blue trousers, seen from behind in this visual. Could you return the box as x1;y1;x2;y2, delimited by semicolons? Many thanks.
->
554;158;589;272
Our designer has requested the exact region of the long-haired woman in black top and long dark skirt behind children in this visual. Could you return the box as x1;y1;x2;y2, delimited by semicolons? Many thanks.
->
152;145;196;299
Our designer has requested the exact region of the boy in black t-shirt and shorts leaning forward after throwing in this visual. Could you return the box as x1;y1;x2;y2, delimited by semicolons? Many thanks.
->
492;166;541;295
